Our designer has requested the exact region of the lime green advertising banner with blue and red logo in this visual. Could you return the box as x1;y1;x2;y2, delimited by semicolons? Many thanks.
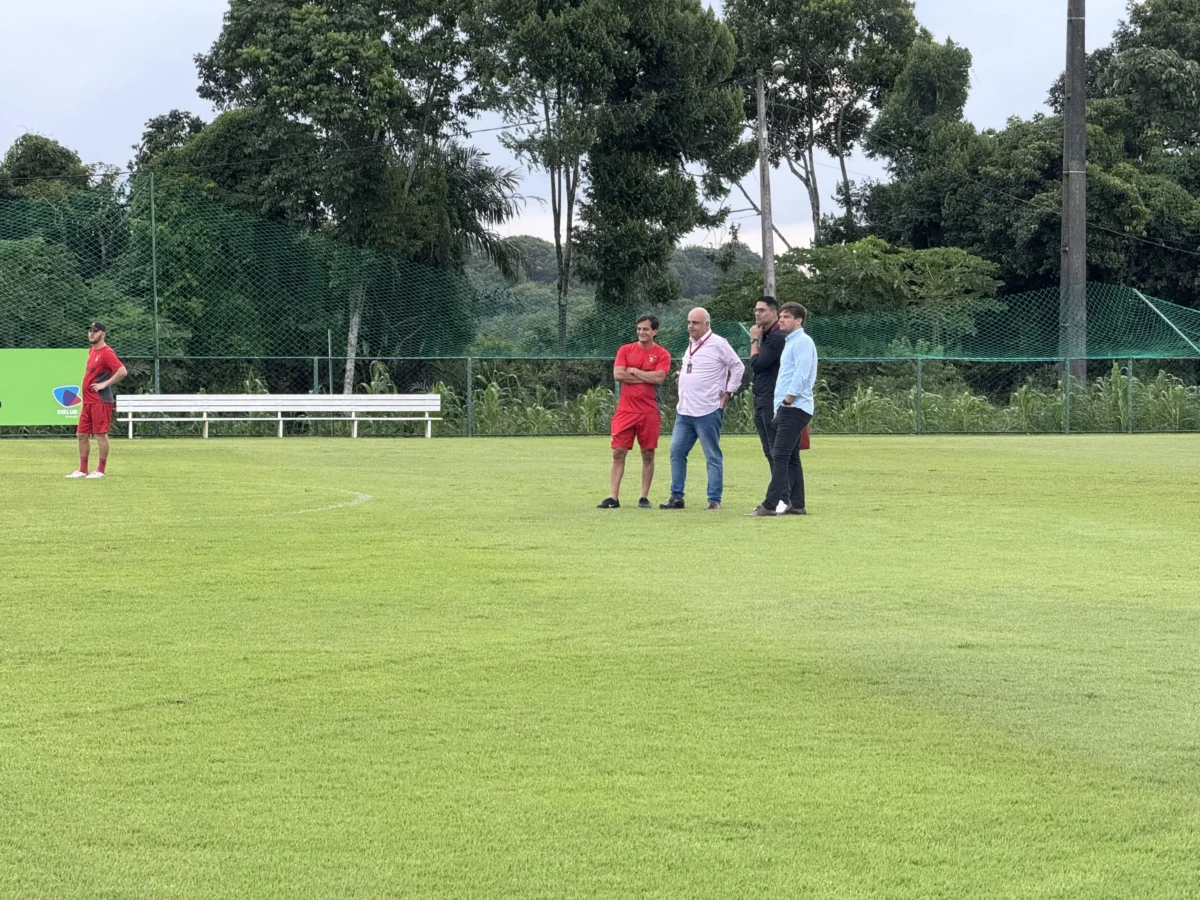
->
0;349;88;426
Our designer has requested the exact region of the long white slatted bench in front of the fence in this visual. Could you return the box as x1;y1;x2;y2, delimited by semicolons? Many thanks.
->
116;394;442;439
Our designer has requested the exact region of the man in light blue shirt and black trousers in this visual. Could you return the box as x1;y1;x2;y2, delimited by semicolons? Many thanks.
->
750;304;817;517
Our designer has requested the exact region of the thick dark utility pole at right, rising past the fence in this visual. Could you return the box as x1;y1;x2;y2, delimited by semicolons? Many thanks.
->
1058;0;1087;380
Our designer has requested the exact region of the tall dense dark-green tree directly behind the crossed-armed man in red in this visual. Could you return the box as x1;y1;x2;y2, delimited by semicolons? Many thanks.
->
578;0;754;306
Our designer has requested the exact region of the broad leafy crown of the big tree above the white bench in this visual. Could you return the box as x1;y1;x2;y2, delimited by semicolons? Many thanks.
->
197;0;496;247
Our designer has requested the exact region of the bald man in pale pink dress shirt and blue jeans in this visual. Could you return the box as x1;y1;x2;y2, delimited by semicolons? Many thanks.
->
661;308;745;509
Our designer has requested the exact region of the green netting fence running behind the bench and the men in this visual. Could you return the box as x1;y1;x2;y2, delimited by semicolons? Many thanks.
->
0;176;1200;434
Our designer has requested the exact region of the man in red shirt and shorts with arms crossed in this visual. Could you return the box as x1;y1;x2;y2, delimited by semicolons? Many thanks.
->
600;316;671;509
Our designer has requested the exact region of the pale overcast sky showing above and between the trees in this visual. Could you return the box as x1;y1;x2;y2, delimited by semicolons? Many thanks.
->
0;0;1127;248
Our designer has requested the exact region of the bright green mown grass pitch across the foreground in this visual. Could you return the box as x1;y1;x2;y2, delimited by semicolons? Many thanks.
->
0;437;1200;899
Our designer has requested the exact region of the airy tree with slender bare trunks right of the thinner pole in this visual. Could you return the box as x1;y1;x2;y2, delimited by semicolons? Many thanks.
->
725;0;917;241
